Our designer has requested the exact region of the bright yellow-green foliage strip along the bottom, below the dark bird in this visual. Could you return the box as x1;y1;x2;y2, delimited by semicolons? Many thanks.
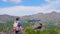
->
25;29;59;34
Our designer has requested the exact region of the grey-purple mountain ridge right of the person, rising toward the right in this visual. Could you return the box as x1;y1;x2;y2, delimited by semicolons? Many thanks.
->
22;11;60;23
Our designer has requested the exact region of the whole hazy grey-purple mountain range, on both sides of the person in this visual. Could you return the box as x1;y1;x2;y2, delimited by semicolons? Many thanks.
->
0;11;60;23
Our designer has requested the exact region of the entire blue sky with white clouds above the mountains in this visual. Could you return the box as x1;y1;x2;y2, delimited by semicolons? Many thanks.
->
0;0;60;16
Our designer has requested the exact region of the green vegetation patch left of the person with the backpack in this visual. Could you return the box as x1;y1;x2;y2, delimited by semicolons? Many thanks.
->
0;21;13;32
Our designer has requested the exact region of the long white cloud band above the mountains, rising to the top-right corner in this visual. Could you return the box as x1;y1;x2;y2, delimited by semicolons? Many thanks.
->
0;0;60;16
